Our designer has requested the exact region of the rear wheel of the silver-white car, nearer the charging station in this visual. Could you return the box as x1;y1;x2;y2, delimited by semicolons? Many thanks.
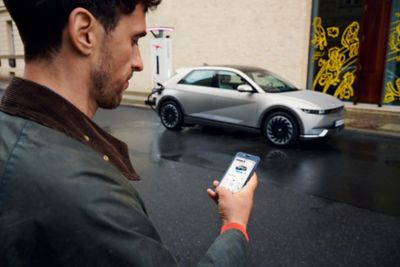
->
159;100;183;131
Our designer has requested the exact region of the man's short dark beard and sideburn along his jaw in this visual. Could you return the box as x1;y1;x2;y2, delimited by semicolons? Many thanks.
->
90;45;123;109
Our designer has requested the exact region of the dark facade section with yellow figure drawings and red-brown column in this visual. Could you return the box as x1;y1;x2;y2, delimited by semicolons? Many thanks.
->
307;0;400;107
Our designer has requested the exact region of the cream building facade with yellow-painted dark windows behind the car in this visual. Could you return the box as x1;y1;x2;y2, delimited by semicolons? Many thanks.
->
0;0;400;110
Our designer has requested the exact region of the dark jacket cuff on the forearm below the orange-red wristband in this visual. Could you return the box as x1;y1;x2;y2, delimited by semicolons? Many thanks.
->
198;229;248;267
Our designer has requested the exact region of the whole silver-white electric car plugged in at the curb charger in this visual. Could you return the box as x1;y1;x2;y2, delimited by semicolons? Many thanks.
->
147;66;345;146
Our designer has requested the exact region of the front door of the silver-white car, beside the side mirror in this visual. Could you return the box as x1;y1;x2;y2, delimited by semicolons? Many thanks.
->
210;71;258;127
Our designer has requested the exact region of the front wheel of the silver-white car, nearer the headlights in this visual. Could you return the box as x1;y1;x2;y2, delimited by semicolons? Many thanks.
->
263;111;299;146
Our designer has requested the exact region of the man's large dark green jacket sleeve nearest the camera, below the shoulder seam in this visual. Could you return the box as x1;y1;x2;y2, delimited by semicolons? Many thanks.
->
0;127;177;267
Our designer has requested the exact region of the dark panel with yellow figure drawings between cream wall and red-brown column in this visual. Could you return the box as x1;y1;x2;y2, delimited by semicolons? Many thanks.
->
308;0;362;101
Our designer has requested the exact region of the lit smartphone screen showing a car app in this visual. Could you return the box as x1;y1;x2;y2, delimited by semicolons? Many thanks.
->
220;157;256;192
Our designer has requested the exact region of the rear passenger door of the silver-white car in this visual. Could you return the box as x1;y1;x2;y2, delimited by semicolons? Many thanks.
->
177;69;216;118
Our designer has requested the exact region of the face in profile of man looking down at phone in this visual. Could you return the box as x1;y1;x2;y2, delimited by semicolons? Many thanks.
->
90;4;146;109
